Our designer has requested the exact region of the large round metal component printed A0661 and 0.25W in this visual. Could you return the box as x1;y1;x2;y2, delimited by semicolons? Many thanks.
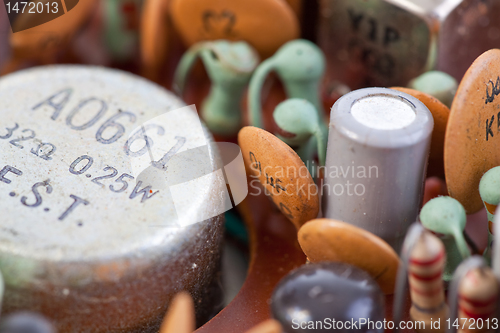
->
0;66;226;332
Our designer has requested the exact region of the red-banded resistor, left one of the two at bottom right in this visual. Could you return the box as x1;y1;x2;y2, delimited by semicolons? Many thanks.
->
408;232;448;333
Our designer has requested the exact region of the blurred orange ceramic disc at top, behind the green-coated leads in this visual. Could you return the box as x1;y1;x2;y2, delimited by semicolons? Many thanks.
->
170;0;300;59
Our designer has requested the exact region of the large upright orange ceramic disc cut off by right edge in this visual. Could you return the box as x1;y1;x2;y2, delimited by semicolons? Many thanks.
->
444;49;500;214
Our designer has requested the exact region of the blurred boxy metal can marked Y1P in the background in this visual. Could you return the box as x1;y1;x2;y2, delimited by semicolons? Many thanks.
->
318;0;500;89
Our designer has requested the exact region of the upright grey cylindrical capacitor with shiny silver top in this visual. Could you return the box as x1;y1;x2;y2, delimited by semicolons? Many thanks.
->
323;88;434;253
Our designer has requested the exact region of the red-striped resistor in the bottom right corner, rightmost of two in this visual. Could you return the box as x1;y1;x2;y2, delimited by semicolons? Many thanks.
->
458;267;499;333
